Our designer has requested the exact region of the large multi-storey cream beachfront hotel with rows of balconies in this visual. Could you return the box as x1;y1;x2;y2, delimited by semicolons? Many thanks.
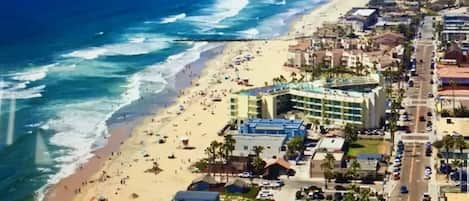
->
230;74;386;128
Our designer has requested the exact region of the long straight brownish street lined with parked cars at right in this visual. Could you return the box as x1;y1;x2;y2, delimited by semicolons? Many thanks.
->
390;17;434;201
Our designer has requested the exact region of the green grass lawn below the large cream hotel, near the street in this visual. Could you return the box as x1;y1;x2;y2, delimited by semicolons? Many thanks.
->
347;139;388;157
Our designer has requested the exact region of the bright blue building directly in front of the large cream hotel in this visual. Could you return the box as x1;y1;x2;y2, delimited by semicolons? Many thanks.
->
239;118;306;140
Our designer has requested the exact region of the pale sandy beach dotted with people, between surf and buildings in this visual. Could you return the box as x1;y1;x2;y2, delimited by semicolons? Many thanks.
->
42;0;368;201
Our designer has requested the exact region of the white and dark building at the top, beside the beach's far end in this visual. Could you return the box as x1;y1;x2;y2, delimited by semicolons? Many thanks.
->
345;8;379;32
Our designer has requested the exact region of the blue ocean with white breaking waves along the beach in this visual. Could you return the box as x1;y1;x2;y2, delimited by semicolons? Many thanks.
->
0;0;327;201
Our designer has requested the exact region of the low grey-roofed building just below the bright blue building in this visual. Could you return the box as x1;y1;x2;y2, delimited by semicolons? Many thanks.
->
233;134;287;160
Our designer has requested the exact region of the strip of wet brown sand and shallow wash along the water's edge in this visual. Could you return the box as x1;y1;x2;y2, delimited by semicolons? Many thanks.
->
39;45;224;201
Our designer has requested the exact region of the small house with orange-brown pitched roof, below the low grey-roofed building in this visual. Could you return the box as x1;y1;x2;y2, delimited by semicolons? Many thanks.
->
263;158;295;179
